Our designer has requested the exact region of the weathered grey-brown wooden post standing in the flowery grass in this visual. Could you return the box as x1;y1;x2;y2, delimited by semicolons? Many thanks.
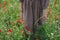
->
20;0;49;40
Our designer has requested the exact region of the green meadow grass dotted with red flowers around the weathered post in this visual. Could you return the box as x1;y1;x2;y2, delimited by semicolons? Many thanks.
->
0;0;60;40
